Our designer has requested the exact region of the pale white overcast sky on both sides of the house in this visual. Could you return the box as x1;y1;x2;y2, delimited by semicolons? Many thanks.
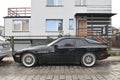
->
0;0;120;28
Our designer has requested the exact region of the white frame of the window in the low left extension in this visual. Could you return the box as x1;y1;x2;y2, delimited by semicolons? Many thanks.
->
12;19;29;32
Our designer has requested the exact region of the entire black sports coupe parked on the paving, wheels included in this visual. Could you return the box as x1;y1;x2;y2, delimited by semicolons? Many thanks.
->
13;37;110;67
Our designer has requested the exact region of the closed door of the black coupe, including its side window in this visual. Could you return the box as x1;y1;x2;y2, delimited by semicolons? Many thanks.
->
55;39;75;63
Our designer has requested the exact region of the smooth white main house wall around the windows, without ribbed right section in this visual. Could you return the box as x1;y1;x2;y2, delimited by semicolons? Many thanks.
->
31;0;87;35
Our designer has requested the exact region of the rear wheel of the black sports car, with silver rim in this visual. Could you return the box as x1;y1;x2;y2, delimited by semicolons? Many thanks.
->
81;53;96;67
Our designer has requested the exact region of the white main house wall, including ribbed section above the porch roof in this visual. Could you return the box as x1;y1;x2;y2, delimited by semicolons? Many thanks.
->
30;0;111;35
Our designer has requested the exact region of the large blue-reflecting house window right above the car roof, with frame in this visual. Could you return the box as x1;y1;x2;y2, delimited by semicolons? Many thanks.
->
46;19;63;31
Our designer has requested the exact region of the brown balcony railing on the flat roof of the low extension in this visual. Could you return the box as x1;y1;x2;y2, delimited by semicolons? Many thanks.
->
8;7;31;16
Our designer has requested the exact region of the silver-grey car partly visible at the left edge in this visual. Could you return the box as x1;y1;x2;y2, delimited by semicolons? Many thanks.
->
0;36;11;61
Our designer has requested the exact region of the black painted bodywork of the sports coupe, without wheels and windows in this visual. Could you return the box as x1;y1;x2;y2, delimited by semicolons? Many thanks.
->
13;38;110;64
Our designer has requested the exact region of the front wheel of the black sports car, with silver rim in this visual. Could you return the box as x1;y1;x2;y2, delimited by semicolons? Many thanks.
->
21;53;37;67
